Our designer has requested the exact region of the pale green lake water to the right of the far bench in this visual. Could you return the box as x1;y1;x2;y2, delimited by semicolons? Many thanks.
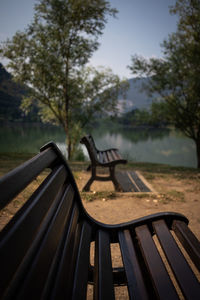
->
90;129;197;167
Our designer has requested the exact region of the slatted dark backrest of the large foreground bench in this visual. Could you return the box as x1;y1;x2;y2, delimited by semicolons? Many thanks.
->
0;143;92;299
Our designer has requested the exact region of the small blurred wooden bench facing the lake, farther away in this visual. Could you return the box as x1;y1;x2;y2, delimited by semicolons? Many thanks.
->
80;135;127;192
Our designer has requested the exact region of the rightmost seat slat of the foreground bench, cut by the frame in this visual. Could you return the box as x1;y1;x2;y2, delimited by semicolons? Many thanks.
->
172;221;200;271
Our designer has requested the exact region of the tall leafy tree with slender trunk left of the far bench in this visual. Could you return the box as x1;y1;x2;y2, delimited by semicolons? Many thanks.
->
0;0;127;159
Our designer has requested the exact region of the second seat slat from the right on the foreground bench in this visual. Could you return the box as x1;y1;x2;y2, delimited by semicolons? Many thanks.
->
153;220;200;300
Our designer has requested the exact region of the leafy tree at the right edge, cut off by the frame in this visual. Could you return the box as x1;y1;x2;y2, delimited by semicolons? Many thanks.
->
130;0;200;168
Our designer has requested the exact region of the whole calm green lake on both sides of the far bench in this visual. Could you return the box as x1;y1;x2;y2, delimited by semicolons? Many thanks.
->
0;124;197;167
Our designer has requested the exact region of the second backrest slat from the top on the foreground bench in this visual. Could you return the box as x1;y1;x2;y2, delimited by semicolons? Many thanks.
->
0;167;66;298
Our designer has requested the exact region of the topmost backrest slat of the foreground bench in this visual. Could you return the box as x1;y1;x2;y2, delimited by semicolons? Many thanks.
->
0;149;56;209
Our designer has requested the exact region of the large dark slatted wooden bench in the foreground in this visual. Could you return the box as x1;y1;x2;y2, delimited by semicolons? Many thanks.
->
0;143;200;300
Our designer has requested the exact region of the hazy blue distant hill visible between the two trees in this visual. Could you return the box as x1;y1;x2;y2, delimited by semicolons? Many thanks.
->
119;78;153;112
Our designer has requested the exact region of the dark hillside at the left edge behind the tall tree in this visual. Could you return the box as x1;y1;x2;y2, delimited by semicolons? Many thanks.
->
0;63;38;121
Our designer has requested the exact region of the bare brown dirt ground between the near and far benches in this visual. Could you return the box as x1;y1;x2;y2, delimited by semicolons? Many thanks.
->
76;172;200;239
